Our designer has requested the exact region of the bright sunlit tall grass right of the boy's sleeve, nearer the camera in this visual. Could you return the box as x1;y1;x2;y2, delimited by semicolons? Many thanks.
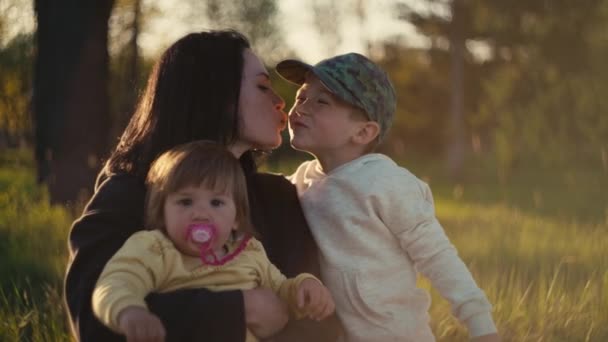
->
422;200;608;341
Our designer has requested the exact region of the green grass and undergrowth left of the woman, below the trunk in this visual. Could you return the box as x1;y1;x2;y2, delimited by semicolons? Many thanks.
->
0;150;73;342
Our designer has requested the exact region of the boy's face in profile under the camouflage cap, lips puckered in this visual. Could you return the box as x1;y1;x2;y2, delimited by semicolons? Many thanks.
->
289;74;367;158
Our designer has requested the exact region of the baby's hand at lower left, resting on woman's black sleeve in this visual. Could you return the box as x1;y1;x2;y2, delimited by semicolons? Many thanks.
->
118;306;165;342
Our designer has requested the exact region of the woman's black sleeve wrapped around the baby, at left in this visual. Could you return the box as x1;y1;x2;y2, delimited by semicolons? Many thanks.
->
64;175;245;342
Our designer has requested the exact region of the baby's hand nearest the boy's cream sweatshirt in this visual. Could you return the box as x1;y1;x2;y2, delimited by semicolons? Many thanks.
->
298;279;335;321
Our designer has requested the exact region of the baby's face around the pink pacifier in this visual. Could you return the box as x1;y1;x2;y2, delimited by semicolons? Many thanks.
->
164;185;237;256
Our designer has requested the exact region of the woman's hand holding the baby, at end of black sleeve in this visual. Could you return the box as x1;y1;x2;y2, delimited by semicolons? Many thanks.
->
243;288;289;338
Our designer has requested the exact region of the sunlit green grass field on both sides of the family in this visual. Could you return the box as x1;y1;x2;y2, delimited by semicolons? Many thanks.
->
0;152;608;342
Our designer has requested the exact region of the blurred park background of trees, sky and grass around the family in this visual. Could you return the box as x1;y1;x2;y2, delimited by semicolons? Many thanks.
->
0;0;608;341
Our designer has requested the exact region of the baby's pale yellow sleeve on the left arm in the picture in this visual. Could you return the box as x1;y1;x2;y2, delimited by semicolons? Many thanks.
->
92;231;171;331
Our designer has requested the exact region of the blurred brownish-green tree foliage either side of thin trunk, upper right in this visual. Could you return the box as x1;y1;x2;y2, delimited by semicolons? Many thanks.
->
387;0;608;180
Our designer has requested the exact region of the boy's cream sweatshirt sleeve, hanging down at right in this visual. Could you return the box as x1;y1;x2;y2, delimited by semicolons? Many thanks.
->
376;169;496;337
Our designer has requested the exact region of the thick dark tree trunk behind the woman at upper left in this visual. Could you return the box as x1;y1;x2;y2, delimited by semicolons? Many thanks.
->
34;0;114;204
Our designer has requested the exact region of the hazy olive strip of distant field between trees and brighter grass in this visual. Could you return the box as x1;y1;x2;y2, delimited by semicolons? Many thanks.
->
401;154;608;225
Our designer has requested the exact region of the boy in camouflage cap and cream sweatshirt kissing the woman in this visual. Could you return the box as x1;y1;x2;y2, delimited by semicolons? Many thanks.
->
277;53;499;342
